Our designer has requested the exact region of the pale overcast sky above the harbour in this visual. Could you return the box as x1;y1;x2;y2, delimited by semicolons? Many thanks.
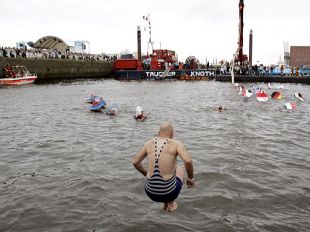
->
0;0;310;64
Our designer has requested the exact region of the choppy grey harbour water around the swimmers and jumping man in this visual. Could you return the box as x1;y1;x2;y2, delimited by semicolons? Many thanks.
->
0;80;310;232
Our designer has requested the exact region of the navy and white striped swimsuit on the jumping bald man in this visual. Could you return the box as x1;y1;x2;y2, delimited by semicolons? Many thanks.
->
145;138;182;202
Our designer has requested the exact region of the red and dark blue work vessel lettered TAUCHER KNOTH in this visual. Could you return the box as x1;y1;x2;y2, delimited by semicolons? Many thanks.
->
114;17;215;80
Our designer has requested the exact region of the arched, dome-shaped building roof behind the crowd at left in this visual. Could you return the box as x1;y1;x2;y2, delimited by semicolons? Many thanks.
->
34;36;69;52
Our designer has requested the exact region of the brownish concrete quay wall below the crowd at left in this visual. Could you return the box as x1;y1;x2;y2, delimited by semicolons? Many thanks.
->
0;57;113;82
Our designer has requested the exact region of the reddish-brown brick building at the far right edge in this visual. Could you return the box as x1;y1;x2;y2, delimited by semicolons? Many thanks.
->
290;46;310;67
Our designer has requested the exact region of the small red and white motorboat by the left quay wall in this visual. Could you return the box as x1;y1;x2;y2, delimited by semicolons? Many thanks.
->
0;65;38;85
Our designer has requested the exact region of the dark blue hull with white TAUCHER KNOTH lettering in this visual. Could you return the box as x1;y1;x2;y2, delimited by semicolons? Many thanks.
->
113;69;215;80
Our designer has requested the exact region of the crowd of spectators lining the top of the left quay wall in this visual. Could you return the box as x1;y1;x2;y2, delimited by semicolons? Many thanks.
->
0;47;116;62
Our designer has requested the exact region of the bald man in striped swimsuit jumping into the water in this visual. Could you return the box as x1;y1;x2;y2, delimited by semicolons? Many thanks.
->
132;122;195;212
